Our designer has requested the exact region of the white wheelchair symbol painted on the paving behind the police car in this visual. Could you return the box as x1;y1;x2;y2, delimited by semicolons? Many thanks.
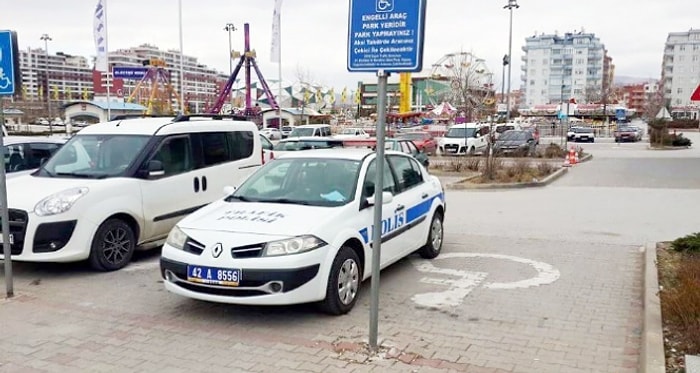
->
411;253;560;309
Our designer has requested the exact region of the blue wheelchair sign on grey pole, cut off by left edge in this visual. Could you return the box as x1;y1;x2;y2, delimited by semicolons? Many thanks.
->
0;31;16;298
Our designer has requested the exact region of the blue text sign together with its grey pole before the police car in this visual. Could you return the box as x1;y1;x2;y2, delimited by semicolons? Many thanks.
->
347;0;427;352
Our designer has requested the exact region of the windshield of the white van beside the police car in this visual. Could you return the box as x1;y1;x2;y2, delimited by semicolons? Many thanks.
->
38;135;150;179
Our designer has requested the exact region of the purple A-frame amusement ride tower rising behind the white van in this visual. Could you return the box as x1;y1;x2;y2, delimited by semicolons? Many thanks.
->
209;23;279;118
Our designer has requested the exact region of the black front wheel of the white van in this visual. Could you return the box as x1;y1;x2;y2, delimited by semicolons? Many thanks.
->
89;219;136;271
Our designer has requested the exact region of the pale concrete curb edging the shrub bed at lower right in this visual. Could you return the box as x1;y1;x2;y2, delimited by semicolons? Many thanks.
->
640;245;666;373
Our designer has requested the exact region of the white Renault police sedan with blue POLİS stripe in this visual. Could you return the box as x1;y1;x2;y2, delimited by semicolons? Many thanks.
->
160;148;445;315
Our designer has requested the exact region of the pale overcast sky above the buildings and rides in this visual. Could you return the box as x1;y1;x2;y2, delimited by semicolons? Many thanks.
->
0;0;700;90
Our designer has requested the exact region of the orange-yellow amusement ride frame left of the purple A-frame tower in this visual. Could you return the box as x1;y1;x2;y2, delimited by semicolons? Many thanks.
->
126;58;182;115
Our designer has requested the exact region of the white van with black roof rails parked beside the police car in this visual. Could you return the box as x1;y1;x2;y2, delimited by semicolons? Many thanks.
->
0;116;263;271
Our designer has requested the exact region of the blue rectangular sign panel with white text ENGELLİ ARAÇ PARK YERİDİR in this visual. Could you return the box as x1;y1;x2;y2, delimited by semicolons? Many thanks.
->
347;0;427;72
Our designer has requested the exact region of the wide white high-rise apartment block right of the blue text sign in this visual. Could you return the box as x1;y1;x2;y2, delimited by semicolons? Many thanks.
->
521;31;614;107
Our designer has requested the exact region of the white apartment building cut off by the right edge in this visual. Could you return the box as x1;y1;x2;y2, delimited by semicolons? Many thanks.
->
661;29;700;112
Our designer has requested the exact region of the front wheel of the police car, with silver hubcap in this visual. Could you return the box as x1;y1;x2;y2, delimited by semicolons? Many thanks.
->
320;246;362;315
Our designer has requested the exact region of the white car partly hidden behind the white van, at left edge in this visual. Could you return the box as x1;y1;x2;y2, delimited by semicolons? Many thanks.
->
3;136;67;178
